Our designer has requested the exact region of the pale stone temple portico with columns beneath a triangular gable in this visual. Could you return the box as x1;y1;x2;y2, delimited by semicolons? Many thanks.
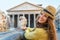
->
7;2;42;27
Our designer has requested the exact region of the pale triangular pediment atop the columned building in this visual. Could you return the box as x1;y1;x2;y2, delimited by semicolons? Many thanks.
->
7;2;41;11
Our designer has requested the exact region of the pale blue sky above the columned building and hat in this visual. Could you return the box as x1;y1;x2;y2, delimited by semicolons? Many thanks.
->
0;0;60;11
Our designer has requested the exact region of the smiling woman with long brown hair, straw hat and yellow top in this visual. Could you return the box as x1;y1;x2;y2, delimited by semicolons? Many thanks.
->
25;6;56;40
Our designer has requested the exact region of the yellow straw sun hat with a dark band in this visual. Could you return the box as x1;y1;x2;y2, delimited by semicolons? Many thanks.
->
42;5;56;19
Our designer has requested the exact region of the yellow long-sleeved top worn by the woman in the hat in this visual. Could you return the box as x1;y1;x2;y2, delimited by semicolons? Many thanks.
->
25;28;48;40
